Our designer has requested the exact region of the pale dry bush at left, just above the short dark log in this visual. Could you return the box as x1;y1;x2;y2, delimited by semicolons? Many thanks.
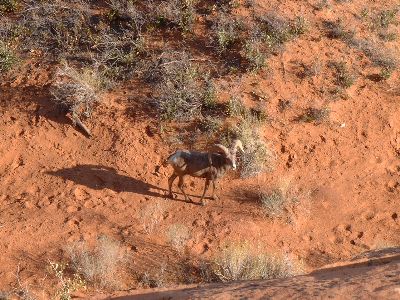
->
50;64;105;117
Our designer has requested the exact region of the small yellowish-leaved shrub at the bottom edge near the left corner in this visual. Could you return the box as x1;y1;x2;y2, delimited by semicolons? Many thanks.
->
50;262;86;300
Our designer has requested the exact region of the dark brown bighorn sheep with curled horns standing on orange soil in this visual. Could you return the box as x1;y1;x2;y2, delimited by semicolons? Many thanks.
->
163;140;244;205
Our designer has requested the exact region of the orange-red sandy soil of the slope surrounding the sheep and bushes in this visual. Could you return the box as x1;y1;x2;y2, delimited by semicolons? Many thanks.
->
0;1;400;299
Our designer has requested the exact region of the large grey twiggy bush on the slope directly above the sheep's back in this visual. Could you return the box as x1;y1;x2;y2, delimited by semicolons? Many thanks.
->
153;53;215;121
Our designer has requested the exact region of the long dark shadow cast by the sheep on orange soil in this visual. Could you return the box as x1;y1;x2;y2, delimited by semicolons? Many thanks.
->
47;165;166;198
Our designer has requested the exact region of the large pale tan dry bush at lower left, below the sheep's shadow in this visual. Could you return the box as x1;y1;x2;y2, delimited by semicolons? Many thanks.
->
66;236;126;288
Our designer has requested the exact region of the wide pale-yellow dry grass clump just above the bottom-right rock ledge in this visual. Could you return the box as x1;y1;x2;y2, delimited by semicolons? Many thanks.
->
212;242;299;282
